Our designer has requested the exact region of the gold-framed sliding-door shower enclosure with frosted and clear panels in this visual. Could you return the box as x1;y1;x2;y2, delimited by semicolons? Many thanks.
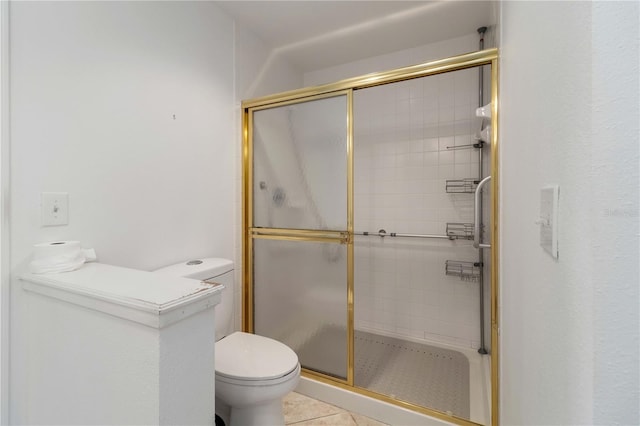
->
243;49;498;424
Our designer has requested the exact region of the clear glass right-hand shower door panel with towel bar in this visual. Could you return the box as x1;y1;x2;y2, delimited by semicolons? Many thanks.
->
354;65;492;424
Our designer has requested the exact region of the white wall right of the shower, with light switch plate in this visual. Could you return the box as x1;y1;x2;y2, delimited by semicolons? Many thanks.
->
500;2;640;425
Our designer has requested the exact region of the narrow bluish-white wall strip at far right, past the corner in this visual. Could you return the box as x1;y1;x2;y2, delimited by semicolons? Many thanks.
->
591;2;640;424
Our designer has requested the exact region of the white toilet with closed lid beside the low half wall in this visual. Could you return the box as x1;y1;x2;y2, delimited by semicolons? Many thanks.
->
155;258;300;426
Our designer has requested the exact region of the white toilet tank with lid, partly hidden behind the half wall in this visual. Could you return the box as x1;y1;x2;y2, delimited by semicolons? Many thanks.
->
154;257;233;340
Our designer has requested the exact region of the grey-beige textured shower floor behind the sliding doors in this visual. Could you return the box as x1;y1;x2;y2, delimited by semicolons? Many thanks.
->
296;326;471;419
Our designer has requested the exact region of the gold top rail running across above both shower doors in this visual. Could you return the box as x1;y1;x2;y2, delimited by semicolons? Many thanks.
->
242;48;498;108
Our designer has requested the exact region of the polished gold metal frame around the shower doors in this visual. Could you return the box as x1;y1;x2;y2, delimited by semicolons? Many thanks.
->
242;48;499;426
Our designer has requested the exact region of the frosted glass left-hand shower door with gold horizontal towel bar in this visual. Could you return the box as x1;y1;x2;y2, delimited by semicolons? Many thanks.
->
245;92;350;380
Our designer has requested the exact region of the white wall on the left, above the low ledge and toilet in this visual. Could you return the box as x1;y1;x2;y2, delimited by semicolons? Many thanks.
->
3;2;237;422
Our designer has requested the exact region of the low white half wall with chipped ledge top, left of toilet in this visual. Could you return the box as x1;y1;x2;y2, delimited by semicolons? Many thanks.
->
20;263;222;425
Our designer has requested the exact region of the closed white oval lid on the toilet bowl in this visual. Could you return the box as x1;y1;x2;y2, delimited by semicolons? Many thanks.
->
215;332;298;380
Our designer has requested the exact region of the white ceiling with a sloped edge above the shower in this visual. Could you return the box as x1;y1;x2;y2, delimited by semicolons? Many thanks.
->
216;0;494;72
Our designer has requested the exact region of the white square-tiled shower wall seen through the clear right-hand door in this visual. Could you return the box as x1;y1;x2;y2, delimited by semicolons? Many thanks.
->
354;69;480;348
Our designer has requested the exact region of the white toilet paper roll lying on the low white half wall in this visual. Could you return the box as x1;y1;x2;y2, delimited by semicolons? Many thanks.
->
29;241;95;274
